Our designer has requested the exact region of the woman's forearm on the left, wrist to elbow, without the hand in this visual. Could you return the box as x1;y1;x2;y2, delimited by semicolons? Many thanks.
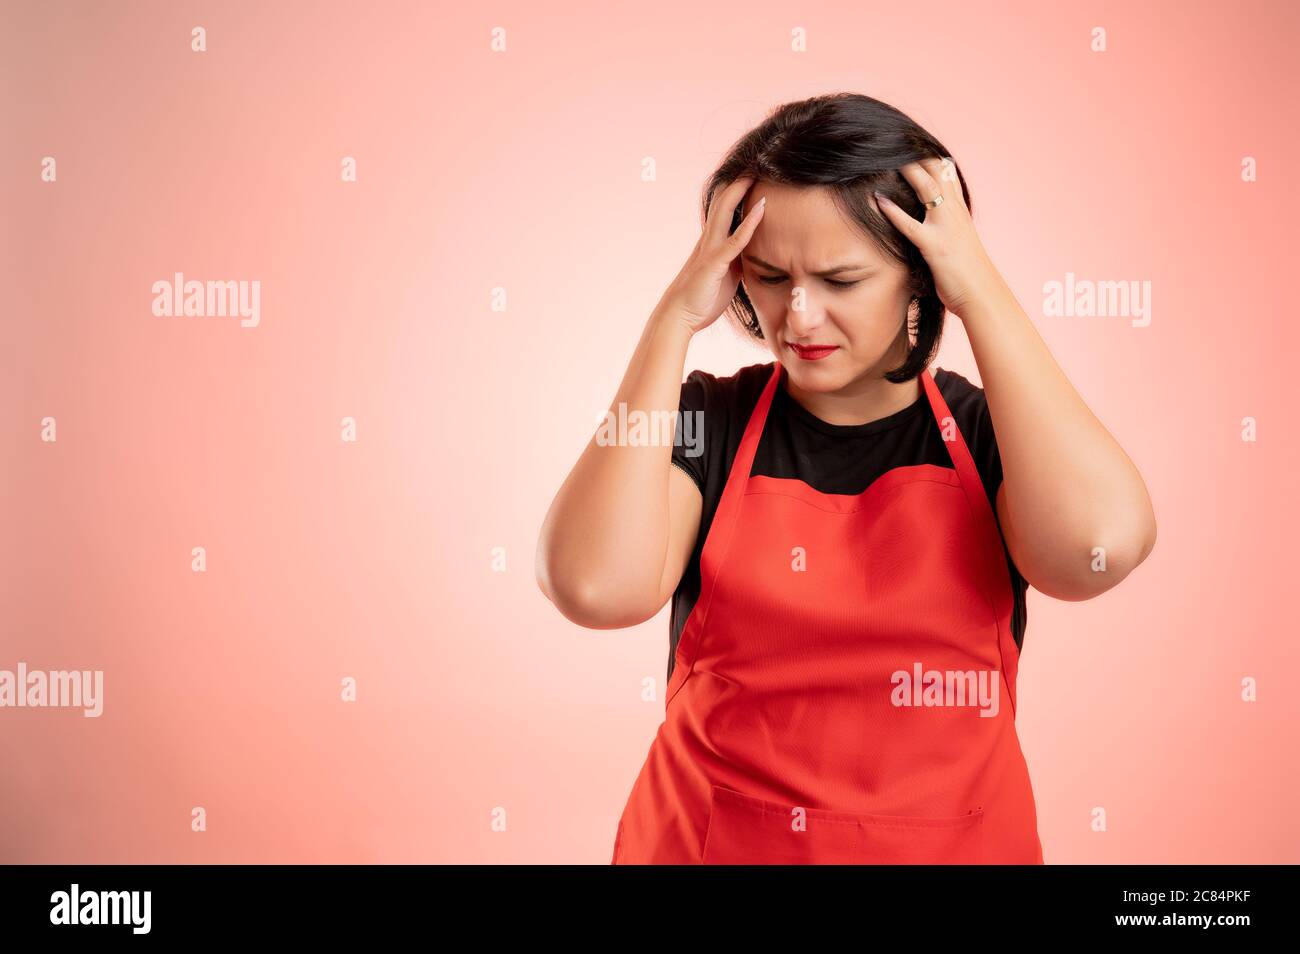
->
537;302;692;626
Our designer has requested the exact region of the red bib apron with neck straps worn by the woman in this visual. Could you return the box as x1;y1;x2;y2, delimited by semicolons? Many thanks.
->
612;361;1043;864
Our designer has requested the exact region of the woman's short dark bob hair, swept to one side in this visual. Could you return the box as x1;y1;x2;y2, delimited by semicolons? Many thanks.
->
701;92;975;383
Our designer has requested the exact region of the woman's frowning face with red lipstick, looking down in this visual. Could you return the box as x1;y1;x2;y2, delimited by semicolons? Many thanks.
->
741;182;911;391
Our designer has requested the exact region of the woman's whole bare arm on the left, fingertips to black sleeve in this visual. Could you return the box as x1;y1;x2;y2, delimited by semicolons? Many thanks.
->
537;179;763;629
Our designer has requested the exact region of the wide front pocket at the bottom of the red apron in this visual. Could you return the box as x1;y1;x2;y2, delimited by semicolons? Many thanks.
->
702;785;984;864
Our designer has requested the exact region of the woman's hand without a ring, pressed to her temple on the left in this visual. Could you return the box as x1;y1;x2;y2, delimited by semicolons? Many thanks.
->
660;175;766;334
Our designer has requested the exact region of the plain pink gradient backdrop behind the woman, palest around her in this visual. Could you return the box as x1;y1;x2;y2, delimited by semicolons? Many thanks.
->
0;1;1300;864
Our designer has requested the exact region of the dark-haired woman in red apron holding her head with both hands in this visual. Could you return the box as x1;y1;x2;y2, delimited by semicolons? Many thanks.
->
537;95;1156;864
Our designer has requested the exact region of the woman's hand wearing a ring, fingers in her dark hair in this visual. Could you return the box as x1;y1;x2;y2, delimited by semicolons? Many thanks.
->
874;159;1005;317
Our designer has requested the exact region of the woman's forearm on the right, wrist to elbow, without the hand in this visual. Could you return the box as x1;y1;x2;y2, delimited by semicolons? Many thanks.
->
961;282;1156;597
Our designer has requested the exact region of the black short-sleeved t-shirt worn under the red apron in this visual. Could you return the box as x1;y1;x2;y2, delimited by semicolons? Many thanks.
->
668;361;1027;678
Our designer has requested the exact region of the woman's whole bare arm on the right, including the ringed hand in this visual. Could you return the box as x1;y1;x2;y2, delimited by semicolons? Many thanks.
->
875;157;1156;600
